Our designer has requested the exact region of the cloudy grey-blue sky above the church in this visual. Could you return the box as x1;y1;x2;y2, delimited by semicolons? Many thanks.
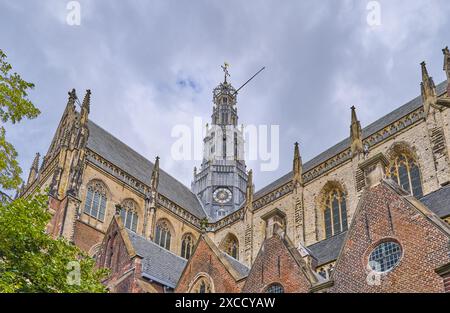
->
0;0;450;189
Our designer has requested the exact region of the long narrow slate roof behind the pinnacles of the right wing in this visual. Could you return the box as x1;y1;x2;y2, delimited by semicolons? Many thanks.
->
255;81;447;199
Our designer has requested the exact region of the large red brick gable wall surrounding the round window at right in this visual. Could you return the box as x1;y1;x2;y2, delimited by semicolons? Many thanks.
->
330;183;449;292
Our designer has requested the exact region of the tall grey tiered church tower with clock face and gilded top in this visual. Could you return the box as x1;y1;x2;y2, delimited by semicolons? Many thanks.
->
192;63;248;220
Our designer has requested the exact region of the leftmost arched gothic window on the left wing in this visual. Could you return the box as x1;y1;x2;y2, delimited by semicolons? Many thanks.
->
84;181;106;222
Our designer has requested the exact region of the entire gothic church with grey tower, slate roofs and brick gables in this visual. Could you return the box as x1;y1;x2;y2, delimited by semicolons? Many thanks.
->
19;48;450;293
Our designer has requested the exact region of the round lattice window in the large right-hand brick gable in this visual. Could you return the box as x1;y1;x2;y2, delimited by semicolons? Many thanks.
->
369;241;402;273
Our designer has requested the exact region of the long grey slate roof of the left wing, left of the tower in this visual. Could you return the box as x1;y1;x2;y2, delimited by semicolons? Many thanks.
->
87;121;206;218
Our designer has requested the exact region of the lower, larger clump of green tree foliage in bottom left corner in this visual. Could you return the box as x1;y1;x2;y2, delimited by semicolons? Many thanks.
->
0;194;108;293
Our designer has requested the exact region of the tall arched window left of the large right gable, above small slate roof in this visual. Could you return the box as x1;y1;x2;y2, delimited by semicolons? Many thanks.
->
323;188;347;238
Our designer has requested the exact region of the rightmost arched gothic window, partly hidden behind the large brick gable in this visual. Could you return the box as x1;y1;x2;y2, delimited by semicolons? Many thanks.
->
386;152;423;199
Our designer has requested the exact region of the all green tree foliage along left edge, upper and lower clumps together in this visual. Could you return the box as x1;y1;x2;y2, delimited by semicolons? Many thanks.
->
0;50;108;292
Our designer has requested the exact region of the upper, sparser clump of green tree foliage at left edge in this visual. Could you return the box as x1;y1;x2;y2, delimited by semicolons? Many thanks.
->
0;50;40;190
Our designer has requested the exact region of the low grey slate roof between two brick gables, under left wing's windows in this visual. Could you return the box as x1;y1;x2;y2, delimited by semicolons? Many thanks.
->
127;230;187;288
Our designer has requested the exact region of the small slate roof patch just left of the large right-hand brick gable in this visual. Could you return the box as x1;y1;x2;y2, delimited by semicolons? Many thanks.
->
308;231;347;265
